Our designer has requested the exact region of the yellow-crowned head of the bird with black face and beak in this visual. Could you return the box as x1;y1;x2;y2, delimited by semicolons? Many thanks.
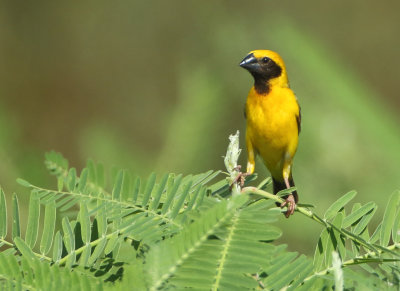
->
239;50;289;93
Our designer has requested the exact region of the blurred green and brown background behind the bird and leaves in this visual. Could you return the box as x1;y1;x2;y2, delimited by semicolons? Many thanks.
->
0;0;400;254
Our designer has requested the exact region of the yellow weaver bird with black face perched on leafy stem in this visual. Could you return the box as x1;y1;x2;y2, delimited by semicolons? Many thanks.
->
239;50;301;217
